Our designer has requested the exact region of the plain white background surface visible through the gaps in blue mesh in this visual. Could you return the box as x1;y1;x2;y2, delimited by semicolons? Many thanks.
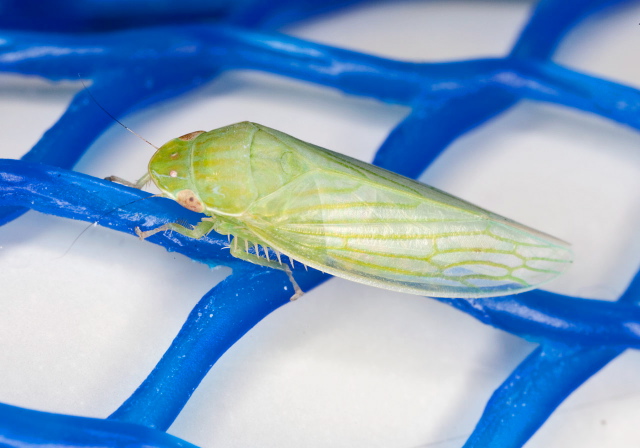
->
0;1;640;448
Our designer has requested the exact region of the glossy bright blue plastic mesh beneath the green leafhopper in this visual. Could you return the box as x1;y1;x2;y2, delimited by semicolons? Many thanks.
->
0;0;640;448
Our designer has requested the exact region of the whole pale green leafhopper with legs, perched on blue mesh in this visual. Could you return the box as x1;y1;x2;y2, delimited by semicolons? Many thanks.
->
110;122;572;300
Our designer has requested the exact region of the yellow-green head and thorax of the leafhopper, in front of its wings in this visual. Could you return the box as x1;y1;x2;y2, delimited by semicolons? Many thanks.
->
149;122;306;214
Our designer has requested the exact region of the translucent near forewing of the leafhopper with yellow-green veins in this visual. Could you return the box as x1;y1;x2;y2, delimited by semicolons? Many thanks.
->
243;169;572;297
